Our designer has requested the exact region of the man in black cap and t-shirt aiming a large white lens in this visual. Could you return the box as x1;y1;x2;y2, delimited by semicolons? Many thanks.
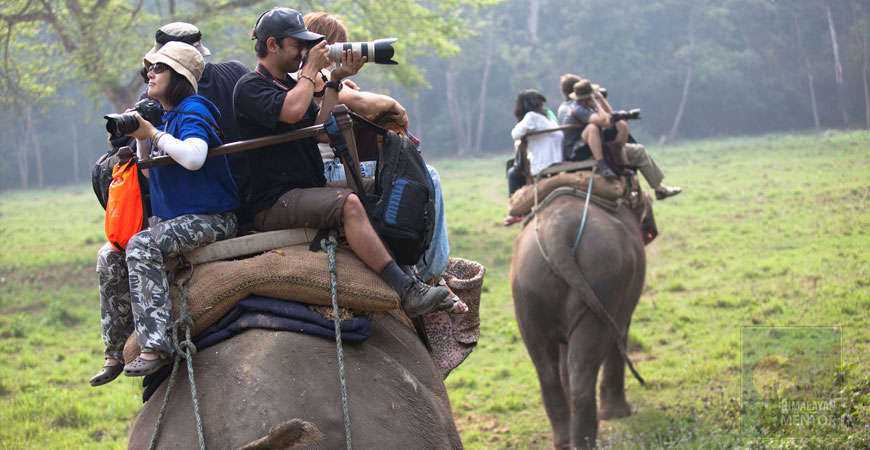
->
233;8;466;317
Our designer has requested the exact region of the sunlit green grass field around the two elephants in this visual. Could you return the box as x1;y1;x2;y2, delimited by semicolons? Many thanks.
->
0;132;870;449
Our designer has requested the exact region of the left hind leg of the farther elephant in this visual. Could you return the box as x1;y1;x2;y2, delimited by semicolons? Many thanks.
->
524;330;571;448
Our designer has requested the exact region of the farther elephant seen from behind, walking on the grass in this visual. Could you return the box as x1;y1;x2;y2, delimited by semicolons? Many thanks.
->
510;194;646;448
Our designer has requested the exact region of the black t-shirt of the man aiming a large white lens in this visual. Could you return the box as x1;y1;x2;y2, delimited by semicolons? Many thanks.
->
233;66;326;220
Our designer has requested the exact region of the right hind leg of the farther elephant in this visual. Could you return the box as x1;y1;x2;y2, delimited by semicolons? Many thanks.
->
567;314;614;449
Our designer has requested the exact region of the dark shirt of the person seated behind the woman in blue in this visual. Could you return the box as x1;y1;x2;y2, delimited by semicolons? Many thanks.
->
197;61;249;144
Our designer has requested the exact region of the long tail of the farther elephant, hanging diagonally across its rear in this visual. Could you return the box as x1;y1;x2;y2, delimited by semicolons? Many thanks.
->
534;216;646;386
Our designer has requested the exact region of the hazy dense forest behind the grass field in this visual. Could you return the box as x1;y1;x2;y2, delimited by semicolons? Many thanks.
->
0;0;870;189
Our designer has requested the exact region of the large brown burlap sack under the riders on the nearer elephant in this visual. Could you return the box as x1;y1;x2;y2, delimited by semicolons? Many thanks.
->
124;244;399;361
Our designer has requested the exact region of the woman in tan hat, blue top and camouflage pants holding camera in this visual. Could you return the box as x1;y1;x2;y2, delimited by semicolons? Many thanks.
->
90;42;239;386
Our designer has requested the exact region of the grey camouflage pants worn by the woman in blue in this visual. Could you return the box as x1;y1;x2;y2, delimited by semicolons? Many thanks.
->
97;213;237;359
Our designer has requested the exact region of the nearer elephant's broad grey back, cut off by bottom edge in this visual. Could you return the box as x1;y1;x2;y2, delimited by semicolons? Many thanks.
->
128;313;462;449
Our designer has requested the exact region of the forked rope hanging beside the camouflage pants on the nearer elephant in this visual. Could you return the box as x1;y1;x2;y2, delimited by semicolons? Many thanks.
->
148;257;205;450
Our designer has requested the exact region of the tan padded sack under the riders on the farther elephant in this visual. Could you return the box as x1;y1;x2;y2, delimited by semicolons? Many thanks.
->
508;171;625;216
